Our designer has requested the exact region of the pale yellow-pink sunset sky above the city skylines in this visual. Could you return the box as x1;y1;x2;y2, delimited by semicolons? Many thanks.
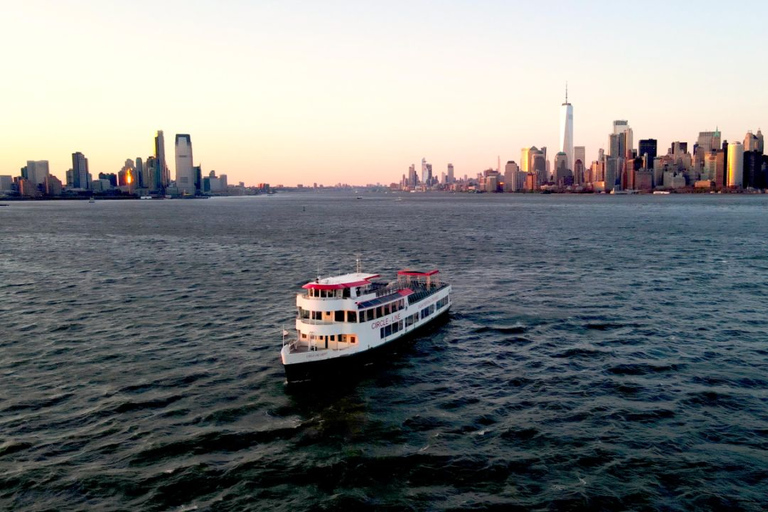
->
0;0;768;186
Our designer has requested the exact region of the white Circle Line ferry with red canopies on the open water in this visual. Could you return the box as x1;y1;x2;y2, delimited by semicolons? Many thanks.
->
280;261;451;383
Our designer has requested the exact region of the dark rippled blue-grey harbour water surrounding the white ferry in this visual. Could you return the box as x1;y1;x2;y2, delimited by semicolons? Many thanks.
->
0;193;768;511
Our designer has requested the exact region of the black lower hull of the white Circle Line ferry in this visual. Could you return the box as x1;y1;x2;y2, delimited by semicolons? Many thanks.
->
284;307;450;384
